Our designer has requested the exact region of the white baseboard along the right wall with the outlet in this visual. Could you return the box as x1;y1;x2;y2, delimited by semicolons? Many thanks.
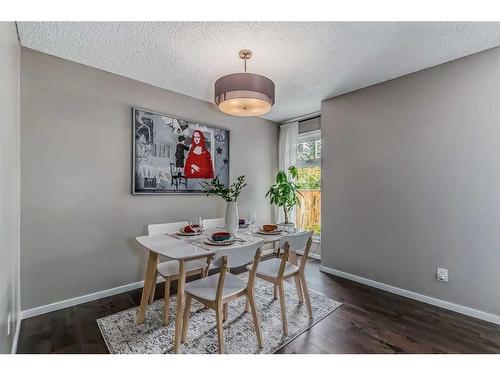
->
319;266;500;325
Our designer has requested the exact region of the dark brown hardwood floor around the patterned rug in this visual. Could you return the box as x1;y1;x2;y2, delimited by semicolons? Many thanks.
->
18;261;500;353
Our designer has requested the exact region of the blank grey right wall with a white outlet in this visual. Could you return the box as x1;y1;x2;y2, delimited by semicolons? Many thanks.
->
322;48;500;315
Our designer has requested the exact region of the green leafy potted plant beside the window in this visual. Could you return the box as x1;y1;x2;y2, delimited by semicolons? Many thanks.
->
266;165;302;227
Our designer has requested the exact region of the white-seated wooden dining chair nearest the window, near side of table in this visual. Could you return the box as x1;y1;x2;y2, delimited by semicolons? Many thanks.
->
245;231;313;335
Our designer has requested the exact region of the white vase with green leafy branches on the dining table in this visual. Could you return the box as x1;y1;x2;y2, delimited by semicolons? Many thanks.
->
201;176;247;233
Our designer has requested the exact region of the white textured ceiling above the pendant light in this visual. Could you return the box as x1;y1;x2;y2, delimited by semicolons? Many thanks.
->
18;22;500;121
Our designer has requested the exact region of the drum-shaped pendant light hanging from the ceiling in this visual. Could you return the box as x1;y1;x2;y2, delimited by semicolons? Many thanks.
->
214;49;274;116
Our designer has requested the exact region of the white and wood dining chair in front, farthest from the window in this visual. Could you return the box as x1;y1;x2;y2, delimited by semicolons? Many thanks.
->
181;240;263;353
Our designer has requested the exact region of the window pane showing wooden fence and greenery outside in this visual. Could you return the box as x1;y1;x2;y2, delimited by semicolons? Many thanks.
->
296;131;321;236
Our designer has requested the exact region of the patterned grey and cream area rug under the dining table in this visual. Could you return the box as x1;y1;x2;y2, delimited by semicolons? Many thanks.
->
97;273;341;354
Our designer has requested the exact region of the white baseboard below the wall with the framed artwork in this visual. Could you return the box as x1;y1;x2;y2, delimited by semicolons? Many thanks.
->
19;277;163;321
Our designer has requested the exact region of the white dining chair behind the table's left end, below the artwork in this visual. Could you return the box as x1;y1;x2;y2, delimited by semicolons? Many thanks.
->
148;221;210;325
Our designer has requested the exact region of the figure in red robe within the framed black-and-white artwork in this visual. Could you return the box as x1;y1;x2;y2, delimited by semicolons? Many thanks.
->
184;130;214;178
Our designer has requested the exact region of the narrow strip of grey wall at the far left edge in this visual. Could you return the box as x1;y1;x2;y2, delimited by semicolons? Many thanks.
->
0;22;20;353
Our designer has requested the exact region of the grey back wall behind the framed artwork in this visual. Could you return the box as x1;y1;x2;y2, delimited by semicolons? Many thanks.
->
21;48;278;309
